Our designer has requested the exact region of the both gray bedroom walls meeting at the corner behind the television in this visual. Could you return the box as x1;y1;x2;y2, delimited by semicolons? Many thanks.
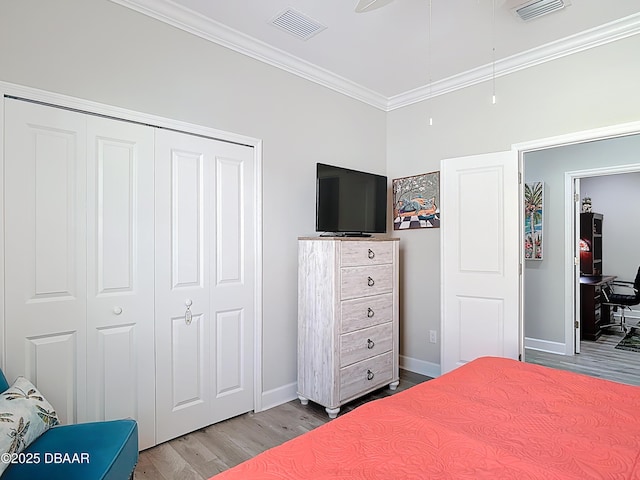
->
0;0;640;384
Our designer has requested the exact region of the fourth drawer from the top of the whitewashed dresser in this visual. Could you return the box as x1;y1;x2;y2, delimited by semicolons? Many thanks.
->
340;322;393;367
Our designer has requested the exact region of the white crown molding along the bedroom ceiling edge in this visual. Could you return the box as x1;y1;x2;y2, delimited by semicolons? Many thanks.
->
110;0;640;112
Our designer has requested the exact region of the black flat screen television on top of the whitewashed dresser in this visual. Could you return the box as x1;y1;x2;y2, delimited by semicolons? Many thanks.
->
316;163;387;236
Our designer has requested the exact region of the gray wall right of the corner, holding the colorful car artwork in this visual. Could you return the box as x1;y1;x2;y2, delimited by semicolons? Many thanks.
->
387;35;640;369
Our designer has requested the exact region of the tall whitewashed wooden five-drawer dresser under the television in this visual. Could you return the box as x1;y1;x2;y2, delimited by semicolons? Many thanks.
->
298;237;399;418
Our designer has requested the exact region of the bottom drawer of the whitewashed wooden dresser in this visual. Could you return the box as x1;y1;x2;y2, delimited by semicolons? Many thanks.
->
340;352;393;402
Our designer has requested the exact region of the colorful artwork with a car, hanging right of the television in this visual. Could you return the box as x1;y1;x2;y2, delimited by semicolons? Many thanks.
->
393;172;440;230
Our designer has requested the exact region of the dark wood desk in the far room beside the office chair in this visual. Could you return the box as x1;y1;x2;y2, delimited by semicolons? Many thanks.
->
580;275;616;340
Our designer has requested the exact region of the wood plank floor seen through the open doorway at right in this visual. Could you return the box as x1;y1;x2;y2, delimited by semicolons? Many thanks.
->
524;327;640;385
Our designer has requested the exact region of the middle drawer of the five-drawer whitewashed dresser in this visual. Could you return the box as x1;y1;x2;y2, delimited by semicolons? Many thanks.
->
340;293;393;333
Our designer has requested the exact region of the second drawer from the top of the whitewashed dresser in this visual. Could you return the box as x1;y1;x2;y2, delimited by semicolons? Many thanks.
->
340;265;393;300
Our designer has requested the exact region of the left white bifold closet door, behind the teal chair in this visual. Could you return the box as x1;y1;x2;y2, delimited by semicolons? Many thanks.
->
4;99;155;448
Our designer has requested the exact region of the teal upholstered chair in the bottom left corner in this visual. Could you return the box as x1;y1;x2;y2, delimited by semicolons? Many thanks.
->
0;370;138;480
